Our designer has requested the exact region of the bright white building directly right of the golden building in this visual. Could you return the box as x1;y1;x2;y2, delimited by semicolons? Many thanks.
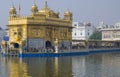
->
72;22;95;40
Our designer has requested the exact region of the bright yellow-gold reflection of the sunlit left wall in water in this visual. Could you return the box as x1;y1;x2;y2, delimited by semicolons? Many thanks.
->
9;58;31;77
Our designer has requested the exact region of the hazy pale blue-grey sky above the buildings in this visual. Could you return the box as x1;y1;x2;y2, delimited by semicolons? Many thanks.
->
0;0;120;28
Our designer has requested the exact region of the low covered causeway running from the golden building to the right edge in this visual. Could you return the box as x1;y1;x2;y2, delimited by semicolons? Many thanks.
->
72;40;120;48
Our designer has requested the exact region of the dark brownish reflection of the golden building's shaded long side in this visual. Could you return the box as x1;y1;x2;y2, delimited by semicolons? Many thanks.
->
20;57;72;77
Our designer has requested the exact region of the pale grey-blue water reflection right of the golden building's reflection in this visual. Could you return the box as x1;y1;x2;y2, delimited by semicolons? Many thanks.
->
72;53;120;77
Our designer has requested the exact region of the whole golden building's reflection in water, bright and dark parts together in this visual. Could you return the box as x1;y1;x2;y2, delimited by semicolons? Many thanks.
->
1;57;72;77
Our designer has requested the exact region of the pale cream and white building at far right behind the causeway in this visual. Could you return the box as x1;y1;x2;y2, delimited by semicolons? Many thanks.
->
101;22;120;41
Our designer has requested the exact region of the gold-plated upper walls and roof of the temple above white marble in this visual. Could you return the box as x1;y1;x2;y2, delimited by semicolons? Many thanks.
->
8;2;72;49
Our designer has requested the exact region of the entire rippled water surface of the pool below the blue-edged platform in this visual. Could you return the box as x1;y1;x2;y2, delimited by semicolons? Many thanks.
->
0;53;120;77
